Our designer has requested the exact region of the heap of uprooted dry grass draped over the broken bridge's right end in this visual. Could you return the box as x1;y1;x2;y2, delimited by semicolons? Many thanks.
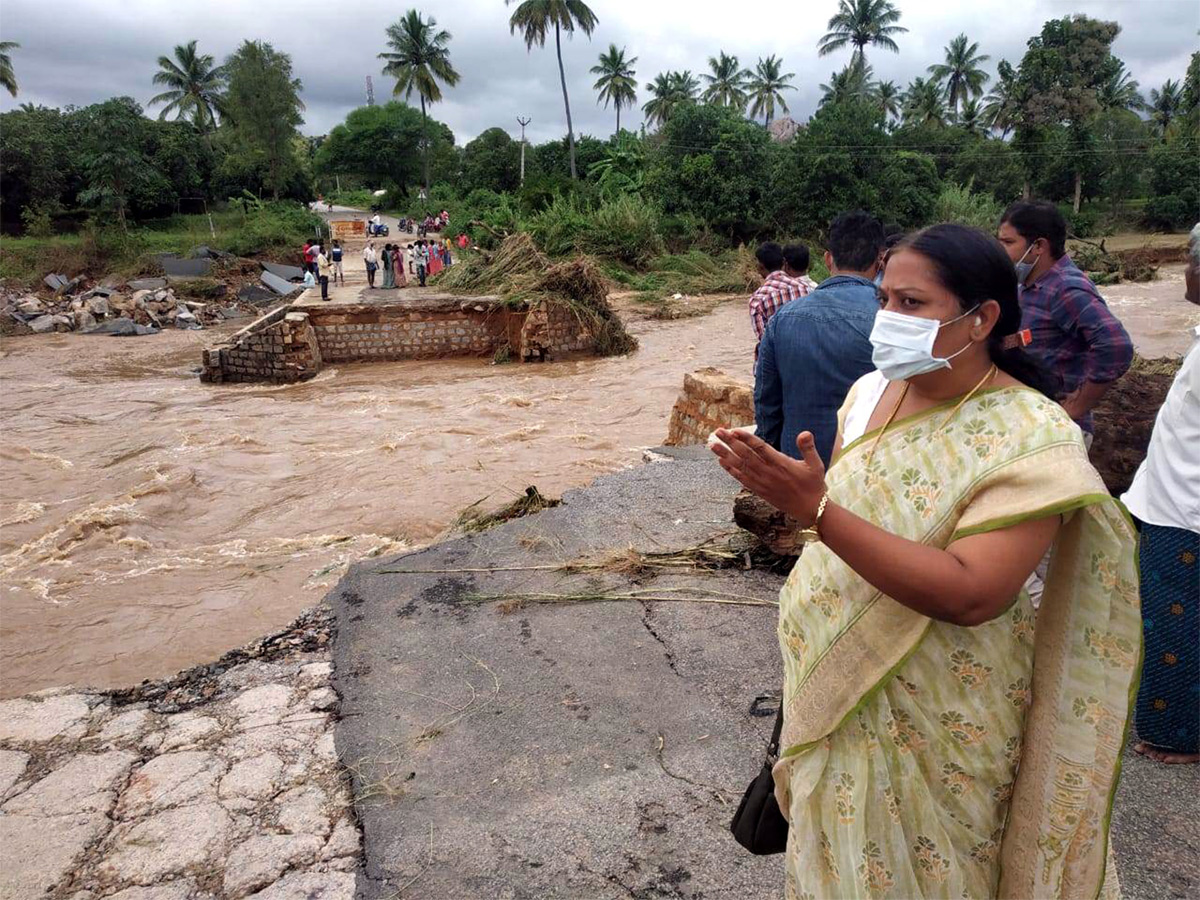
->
434;232;637;356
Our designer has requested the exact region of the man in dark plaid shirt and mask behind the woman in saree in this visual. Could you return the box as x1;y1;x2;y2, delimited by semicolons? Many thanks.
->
996;202;1133;443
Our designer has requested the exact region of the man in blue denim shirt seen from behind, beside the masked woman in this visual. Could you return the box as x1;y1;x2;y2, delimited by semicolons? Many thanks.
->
754;210;883;466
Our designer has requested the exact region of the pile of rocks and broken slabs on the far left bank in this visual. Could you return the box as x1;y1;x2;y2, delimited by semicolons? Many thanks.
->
0;278;259;336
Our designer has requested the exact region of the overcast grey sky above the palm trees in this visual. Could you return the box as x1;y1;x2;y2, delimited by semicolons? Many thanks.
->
0;0;1200;143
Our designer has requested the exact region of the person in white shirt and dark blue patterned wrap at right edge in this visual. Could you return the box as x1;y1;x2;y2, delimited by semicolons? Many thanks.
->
1121;228;1200;763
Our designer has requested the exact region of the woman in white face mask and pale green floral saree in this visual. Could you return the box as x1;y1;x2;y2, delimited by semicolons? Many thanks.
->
714;226;1141;900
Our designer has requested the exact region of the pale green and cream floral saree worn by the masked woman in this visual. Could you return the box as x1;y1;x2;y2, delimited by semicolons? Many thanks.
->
774;388;1141;900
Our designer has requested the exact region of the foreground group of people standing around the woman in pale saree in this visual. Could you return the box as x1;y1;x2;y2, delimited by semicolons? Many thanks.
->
713;202;1200;898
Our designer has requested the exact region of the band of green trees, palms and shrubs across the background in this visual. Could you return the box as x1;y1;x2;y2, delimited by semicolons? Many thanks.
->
0;0;1200;294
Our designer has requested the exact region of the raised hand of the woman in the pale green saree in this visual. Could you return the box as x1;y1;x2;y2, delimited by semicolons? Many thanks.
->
712;428;826;526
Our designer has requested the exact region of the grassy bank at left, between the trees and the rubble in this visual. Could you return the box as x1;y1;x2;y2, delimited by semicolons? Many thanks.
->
0;203;322;287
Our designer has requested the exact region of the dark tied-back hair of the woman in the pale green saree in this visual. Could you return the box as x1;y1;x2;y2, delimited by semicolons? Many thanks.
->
893;224;1062;397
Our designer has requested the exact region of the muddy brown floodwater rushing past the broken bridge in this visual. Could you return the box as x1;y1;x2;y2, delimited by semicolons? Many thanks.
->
0;269;1200;696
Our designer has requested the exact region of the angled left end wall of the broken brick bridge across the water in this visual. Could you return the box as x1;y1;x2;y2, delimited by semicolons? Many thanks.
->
200;304;322;384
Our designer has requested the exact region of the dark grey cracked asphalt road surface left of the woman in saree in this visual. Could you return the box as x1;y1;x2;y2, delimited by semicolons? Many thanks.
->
331;457;782;898
